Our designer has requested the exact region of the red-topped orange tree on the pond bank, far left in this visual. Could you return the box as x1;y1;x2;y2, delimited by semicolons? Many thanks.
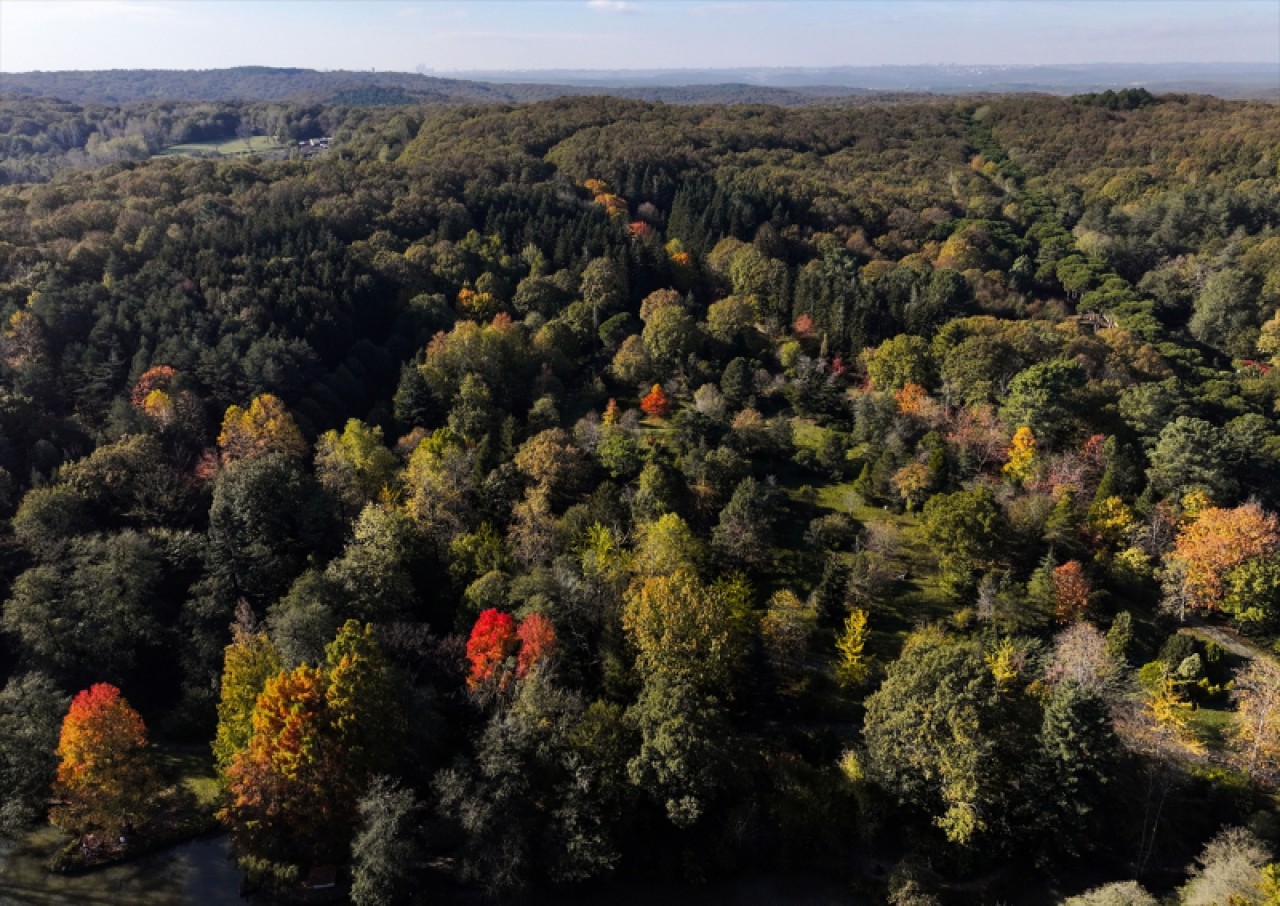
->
49;683;156;837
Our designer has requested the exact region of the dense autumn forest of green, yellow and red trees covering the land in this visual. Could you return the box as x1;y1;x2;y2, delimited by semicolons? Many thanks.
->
0;87;1280;906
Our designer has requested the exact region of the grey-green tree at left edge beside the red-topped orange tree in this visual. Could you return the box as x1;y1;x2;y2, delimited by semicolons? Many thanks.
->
0;673;68;837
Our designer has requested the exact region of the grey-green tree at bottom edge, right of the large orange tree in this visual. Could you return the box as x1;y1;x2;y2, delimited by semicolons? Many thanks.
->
351;777;422;906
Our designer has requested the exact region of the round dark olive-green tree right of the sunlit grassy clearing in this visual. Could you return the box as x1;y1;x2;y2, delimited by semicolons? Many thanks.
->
924;488;1004;591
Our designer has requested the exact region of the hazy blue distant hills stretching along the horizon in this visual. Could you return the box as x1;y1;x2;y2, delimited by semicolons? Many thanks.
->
0;63;1280;105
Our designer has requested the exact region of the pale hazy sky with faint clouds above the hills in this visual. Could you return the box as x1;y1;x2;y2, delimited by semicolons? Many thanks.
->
0;0;1280;72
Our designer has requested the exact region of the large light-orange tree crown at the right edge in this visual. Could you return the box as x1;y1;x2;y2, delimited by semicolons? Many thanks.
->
1174;503;1280;610
